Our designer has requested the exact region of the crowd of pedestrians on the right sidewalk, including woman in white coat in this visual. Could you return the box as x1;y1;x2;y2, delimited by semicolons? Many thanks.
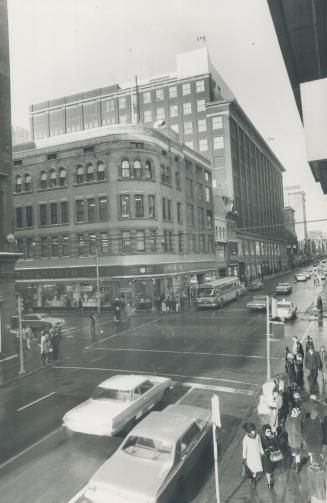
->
242;336;327;490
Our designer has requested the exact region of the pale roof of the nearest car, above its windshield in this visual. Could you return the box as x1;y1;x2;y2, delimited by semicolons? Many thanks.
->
131;411;194;442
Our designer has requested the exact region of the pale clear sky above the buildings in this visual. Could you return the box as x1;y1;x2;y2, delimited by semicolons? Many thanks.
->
7;0;327;232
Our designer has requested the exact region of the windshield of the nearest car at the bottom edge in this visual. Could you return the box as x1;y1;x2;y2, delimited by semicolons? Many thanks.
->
122;435;172;461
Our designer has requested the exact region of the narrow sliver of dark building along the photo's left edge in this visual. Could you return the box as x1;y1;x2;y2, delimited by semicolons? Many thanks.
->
0;0;17;354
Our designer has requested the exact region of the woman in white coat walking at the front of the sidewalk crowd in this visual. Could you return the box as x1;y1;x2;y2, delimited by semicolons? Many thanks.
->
243;423;264;488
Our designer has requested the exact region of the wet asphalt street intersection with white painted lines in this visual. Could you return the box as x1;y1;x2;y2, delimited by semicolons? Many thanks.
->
0;274;317;503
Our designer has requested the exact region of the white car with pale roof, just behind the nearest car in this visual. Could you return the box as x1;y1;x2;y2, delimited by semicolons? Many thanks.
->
63;374;173;436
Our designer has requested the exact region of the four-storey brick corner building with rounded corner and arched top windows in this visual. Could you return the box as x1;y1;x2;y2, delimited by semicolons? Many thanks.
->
13;125;217;308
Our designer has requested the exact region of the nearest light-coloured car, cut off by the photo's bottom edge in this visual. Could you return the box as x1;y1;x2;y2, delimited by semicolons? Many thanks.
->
83;405;211;503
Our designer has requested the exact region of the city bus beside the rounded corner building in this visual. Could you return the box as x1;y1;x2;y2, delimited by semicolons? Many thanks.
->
196;276;241;308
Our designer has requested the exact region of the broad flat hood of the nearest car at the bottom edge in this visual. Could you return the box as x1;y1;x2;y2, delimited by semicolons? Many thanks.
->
85;451;171;502
